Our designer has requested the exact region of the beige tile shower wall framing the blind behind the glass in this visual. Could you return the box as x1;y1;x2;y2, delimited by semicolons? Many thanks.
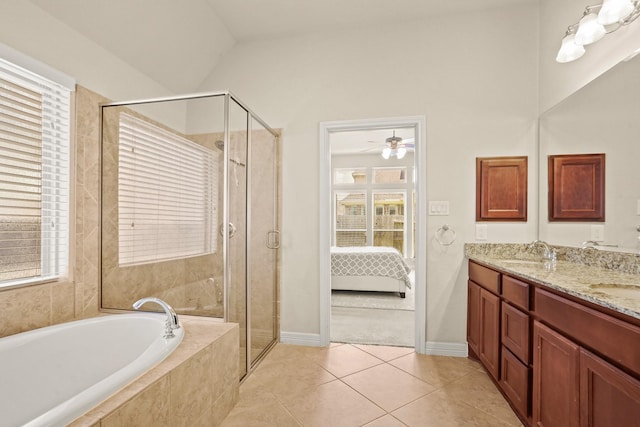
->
102;107;224;317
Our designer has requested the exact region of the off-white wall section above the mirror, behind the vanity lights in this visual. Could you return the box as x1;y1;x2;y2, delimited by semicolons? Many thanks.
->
540;0;640;112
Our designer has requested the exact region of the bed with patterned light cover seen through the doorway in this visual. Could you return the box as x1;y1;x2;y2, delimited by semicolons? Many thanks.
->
331;246;411;298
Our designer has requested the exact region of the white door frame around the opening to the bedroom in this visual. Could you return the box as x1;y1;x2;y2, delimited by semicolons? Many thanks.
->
319;116;427;354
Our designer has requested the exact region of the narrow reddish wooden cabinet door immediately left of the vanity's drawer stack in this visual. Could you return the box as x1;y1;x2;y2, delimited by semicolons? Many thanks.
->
478;289;500;380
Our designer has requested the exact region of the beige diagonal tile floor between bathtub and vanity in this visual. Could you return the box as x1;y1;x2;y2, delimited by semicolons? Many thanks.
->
222;344;521;427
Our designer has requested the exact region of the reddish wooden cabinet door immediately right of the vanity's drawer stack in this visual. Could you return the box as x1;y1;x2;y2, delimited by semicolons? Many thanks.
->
533;321;580;427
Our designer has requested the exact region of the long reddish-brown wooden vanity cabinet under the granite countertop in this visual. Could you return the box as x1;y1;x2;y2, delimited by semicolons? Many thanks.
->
467;261;640;427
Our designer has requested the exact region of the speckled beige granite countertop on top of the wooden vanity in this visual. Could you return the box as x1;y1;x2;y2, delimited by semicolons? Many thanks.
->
465;248;640;319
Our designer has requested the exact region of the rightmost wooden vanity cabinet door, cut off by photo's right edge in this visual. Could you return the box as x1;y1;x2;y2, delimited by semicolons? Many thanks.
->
580;349;640;427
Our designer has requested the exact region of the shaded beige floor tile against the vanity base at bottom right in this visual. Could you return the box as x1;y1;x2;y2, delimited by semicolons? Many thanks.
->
442;370;521;426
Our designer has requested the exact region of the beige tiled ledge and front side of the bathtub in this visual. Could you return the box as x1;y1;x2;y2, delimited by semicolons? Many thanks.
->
69;316;239;427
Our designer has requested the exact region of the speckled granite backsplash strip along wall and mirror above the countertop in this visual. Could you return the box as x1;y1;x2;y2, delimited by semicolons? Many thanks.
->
464;243;640;274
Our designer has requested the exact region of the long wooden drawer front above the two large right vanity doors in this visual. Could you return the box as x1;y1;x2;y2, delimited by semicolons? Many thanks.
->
534;288;640;375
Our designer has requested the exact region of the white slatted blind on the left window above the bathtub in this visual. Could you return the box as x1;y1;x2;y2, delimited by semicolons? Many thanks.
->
0;59;71;286
